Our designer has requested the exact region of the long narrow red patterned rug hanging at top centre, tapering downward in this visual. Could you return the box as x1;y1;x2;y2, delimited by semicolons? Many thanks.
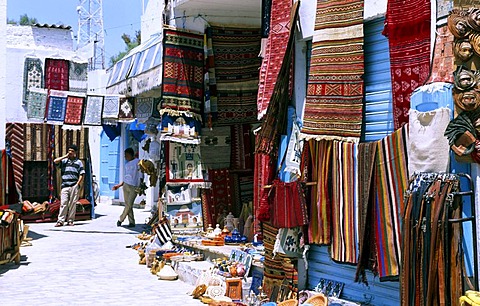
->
257;0;292;119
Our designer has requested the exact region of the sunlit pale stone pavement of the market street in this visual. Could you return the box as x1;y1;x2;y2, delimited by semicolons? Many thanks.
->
0;204;204;306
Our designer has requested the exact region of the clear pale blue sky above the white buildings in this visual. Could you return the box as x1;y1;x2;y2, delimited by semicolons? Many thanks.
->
7;0;142;68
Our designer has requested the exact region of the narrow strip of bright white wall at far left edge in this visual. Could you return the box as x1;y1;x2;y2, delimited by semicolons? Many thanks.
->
0;1;7;150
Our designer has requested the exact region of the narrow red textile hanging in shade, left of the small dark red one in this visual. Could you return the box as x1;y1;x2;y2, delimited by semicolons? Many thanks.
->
253;153;275;233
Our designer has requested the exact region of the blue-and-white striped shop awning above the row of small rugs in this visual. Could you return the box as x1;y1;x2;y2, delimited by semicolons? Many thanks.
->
107;33;163;96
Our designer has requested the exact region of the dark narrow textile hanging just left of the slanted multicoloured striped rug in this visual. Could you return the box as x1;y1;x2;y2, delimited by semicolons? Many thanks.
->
355;141;378;285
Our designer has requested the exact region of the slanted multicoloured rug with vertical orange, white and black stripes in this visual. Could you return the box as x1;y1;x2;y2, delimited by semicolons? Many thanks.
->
374;125;408;279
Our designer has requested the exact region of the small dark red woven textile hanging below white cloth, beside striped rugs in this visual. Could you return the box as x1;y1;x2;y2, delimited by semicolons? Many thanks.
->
272;180;308;228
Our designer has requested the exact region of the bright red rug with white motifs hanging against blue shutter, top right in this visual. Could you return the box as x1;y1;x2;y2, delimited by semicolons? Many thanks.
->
383;0;431;130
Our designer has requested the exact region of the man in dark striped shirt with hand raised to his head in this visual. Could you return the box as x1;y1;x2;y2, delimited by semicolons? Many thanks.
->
53;144;85;227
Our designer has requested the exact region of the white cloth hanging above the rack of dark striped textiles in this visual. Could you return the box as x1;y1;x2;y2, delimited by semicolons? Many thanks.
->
407;108;451;173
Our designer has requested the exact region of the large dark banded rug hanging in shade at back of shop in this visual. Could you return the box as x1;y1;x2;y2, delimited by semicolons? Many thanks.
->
209;27;261;125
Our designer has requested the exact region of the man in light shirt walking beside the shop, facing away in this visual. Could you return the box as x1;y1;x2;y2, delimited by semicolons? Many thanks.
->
112;148;142;227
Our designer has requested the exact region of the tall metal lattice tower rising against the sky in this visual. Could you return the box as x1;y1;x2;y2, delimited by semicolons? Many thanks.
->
77;0;105;70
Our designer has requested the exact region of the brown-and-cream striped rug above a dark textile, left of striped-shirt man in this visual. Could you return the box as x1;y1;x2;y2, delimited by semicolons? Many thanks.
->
23;123;49;161
